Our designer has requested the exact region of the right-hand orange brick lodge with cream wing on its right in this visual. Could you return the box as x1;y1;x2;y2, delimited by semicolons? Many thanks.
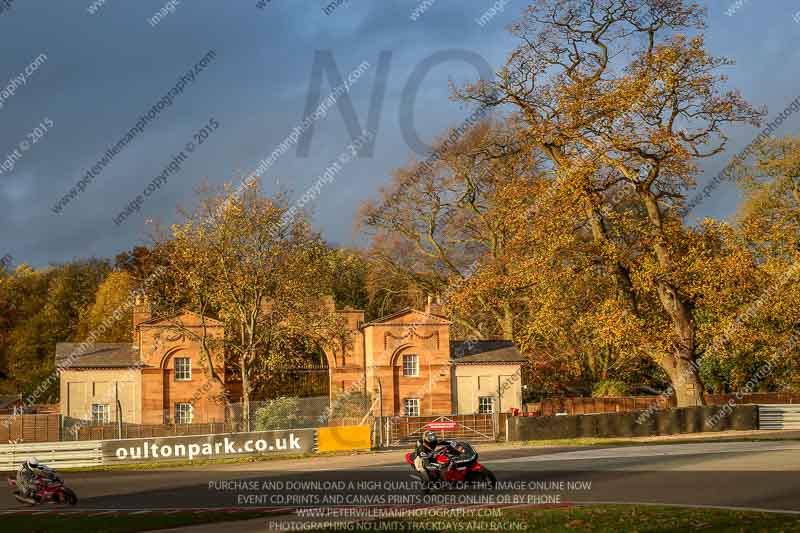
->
327;302;525;416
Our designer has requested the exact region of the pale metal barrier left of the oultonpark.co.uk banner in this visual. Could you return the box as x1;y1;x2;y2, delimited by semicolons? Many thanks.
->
0;440;103;471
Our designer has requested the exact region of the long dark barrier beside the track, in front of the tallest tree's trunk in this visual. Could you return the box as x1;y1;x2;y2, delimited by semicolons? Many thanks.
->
508;405;758;440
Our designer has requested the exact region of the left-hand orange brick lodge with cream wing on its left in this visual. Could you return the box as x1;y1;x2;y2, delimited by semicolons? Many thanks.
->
56;300;225;424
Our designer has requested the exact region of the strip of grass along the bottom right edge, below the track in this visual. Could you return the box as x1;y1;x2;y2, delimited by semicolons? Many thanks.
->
315;505;800;533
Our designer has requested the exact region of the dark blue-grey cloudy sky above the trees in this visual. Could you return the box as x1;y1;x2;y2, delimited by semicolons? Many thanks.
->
0;0;800;267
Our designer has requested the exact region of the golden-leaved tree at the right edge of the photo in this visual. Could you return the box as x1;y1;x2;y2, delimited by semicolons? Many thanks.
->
701;136;800;390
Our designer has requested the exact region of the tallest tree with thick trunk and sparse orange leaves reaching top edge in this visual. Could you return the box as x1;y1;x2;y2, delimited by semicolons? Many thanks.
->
458;0;760;405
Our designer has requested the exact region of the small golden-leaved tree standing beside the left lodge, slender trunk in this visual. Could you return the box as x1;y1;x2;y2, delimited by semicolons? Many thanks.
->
167;183;344;426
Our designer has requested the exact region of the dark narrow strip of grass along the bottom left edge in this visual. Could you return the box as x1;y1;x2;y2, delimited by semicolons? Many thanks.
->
0;512;267;533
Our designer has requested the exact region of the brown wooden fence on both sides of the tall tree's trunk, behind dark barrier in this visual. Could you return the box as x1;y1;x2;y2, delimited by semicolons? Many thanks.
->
525;392;800;416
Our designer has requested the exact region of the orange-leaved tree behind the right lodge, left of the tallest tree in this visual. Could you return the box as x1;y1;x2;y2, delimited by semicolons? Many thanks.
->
450;143;657;394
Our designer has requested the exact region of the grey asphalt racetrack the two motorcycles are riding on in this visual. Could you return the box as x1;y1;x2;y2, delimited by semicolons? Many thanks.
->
0;440;800;531
